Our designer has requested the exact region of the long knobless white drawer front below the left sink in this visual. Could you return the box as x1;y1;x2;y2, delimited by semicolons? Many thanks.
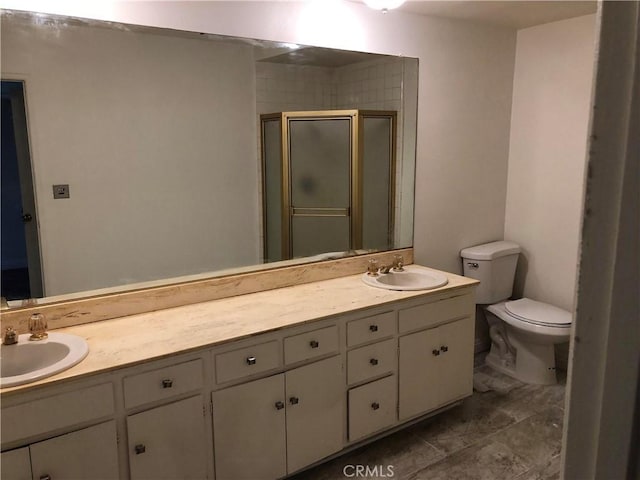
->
2;383;114;445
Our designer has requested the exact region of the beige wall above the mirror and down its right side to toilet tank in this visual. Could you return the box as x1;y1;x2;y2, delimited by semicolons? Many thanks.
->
4;0;516;280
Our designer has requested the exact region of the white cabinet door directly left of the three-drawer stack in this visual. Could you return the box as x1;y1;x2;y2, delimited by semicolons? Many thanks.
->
285;356;345;473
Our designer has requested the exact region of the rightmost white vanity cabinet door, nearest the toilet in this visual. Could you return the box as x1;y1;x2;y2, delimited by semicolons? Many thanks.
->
438;317;474;405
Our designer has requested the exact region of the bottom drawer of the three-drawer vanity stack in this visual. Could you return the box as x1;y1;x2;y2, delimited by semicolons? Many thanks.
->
349;375;398;441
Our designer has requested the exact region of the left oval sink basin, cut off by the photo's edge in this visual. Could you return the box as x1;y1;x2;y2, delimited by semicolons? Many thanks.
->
0;333;89;388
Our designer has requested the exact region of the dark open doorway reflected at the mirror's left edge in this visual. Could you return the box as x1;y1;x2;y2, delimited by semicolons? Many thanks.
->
0;80;43;300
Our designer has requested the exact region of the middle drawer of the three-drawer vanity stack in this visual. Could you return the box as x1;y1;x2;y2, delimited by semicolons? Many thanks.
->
347;338;397;385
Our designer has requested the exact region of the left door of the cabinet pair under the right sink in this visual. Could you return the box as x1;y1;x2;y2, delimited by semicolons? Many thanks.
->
398;328;440;420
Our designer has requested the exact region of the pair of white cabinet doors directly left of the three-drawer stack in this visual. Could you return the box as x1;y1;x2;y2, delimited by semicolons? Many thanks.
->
212;356;344;480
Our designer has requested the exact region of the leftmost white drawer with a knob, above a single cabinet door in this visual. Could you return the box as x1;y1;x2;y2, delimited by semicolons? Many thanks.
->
124;360;203;408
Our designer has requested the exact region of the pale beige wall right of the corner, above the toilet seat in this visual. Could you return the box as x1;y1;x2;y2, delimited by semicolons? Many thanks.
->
504;15;595;311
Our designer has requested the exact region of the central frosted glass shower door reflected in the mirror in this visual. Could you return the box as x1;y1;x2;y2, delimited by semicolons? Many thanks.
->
287;116;353;258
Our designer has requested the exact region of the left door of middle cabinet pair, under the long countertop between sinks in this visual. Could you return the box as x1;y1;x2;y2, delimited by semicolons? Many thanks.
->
212;374;287;480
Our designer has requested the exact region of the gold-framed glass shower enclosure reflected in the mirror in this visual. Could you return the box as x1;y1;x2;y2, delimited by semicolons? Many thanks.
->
260;110;396;262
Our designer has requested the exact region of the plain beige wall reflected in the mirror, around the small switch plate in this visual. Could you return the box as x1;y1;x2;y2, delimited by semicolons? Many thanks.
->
2;18;259;295
